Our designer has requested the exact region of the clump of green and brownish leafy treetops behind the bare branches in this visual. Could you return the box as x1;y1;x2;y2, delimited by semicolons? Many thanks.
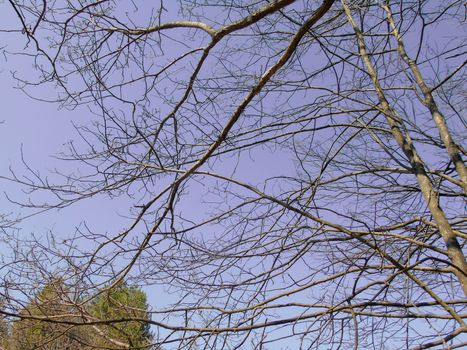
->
4;280;152;350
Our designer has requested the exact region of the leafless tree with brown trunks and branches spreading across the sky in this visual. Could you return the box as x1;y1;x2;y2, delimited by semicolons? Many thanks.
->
0;0;467;349
